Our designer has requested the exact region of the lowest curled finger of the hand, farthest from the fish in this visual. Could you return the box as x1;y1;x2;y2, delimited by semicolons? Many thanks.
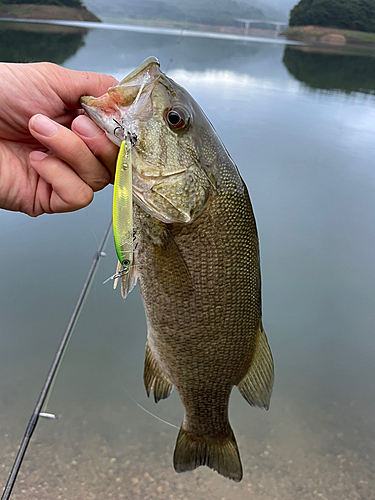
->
29;151;94;214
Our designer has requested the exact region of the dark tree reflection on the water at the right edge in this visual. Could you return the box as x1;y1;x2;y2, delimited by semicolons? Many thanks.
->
283;47;375;94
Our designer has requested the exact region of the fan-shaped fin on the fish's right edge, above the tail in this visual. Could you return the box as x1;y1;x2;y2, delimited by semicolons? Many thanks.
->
237;323;274;410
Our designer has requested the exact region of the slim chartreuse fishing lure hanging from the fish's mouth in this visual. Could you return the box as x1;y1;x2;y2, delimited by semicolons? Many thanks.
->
113;140;133;272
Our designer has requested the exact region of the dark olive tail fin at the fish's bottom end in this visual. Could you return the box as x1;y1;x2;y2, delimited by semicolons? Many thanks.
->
173;424;242;482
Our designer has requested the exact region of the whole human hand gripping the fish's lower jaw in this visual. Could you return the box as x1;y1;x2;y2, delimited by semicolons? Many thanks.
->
0;63;118;217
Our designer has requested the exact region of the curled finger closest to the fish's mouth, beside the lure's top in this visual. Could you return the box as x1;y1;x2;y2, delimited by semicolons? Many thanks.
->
72;115;118;181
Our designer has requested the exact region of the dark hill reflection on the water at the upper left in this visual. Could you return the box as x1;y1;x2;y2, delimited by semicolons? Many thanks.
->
0;22;87;64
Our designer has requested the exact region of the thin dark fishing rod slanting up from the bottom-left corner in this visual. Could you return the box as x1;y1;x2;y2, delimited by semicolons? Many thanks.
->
1;218;112;500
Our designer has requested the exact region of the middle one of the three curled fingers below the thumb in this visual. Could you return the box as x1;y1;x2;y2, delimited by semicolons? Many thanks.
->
29;115;111;191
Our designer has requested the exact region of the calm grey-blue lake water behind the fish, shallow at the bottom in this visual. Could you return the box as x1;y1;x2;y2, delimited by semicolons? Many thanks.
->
0;19;375;500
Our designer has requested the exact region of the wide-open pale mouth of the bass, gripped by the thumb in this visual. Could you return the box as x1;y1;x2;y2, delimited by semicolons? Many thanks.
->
80;56;162;146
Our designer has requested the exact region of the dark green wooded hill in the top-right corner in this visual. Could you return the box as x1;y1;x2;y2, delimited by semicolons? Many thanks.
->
289;0;375;33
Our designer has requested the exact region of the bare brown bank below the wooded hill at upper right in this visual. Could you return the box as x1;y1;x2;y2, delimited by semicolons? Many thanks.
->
281;26;375;47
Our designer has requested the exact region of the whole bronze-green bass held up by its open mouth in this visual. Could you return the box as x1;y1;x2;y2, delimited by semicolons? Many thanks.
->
81;57;274;482
